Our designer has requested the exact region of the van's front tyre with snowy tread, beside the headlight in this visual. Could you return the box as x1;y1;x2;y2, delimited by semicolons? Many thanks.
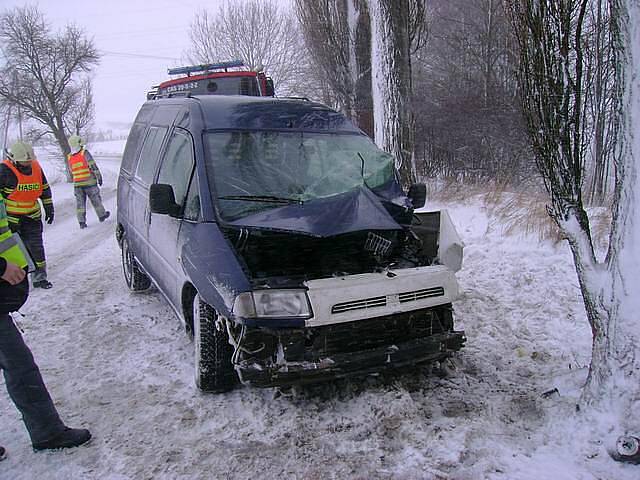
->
193;295;238;393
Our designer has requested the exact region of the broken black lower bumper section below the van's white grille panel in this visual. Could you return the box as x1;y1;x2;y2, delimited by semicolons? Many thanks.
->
236;306;466;387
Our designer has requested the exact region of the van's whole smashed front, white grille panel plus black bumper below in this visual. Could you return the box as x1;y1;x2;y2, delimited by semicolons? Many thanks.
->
230;265;466;387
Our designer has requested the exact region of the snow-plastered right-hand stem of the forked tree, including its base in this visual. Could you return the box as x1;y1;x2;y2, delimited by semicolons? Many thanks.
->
585;0;640;435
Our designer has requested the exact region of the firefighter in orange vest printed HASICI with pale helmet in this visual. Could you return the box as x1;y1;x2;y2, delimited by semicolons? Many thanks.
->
0;142;53;288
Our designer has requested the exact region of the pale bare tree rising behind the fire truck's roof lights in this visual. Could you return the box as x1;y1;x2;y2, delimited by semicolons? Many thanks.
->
187;0;309;95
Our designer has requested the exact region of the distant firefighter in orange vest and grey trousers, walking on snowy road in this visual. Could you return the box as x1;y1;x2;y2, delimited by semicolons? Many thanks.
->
67;135;110;228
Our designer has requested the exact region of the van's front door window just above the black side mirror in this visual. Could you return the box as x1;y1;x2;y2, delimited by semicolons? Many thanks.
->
158;129;194;206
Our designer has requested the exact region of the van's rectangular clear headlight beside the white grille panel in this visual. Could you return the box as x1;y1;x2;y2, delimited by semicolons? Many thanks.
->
233;289;311;318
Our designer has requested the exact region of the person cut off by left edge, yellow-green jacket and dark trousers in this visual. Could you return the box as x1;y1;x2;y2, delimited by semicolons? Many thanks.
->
0;192;91;459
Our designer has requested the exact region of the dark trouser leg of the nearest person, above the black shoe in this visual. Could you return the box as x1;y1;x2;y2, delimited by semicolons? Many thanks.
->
0;313;65;443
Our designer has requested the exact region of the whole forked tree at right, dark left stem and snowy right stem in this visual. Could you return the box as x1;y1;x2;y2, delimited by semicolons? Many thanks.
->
509;0;640;444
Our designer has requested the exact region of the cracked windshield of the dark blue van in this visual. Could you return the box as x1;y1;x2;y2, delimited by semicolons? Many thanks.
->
205;131;394;220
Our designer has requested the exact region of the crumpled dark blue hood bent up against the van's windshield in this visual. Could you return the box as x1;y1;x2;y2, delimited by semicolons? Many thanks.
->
228;187;402;237
